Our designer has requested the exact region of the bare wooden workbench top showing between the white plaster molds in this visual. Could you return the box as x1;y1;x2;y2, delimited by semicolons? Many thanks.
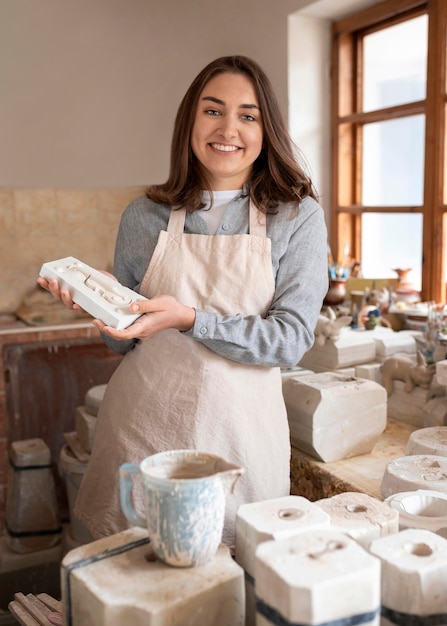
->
291;419;419;502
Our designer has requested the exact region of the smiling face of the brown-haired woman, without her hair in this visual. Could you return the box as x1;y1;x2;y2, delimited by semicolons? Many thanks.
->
191;73;263;191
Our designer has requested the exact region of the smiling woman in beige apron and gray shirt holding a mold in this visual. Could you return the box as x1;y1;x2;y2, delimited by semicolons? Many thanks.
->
39;56;328;546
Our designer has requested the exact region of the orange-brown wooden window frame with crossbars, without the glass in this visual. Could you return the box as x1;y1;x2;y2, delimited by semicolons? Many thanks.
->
330;0;447;302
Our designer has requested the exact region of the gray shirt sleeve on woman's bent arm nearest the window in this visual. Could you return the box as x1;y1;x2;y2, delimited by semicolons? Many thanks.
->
186;198;328;367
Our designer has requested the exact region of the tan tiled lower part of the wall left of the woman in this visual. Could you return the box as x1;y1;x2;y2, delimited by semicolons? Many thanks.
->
0;187;143;313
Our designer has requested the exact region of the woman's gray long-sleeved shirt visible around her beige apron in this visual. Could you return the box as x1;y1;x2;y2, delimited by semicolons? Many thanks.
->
103;194;328;367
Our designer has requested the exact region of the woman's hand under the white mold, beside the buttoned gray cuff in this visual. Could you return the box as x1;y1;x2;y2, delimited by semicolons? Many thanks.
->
93;296;196;340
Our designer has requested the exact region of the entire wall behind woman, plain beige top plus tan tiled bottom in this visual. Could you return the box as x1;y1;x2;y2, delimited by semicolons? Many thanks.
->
0;0;378;313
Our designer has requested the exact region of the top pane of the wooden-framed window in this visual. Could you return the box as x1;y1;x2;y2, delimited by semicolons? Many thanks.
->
363;15;428;111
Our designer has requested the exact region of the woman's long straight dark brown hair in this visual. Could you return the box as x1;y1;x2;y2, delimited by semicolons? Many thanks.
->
146;56;316;213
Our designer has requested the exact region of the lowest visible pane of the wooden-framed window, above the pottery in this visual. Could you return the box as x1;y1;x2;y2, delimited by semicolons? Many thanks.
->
361;213;422;290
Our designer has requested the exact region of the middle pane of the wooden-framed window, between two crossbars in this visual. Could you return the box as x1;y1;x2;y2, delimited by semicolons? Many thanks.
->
362;115;425;206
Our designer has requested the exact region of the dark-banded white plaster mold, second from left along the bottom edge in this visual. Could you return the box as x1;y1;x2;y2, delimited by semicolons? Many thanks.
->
255;529;380;626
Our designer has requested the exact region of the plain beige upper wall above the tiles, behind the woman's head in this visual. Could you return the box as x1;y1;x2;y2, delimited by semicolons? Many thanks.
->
0;0;316;188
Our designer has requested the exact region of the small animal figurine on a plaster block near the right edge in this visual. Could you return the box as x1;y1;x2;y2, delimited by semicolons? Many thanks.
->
382;351;436;396
